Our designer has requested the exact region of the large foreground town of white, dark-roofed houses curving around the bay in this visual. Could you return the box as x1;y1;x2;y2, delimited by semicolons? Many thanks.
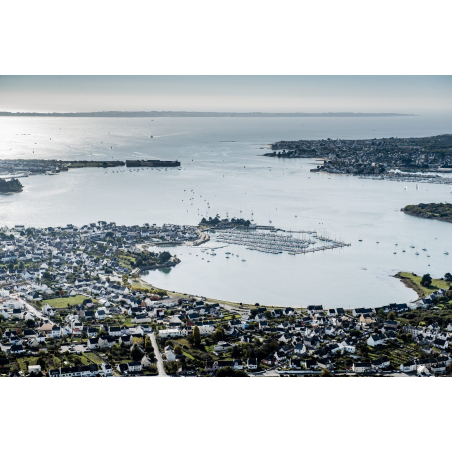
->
0;221;452;377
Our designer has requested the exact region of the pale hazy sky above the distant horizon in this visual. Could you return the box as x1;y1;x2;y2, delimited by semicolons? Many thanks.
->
0;75;452;113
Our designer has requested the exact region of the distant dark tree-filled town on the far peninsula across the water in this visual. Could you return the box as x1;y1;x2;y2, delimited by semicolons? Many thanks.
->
264;135;452;178
